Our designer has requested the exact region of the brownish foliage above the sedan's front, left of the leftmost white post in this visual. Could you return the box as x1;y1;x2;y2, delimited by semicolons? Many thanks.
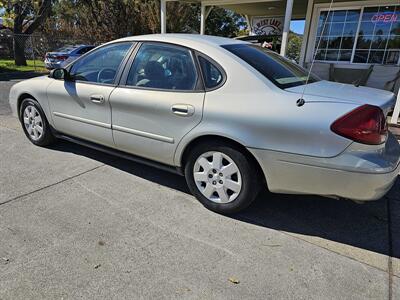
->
45;0;157;43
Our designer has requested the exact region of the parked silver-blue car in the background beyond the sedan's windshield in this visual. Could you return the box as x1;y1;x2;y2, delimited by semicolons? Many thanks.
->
44;45;95;70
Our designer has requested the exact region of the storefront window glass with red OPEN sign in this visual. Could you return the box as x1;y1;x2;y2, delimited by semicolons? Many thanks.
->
315;5;400;64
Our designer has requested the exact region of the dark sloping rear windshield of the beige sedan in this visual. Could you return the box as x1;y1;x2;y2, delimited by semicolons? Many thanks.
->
222;44;319;89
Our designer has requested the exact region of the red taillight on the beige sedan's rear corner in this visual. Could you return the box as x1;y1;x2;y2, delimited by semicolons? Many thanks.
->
331;104;388;145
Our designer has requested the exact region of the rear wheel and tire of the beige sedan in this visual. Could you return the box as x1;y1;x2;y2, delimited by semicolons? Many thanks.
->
185;142;261;214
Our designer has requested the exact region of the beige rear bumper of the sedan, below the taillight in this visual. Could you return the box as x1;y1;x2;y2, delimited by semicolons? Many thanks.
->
249;135;400;201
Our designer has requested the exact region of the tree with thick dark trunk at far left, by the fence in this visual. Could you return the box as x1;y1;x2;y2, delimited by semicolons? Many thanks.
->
0;0;52;66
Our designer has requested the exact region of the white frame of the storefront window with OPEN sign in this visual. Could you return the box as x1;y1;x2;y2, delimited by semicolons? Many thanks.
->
305;0;400;67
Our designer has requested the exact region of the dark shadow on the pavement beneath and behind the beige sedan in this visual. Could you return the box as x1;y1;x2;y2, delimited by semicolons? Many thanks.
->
52;141;400;258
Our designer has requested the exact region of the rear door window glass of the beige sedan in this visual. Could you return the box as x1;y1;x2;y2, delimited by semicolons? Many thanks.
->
126;43;197;91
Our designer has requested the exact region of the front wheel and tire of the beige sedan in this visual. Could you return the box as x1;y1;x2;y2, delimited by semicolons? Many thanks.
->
19;98;56;147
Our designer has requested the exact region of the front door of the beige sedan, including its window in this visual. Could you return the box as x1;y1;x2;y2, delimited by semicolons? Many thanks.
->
47;42;132;146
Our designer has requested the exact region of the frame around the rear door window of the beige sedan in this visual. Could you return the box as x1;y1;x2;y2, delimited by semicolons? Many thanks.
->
118;41;205;93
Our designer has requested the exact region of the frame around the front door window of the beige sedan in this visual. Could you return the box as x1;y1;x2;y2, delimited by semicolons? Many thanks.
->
65;41;138;87
